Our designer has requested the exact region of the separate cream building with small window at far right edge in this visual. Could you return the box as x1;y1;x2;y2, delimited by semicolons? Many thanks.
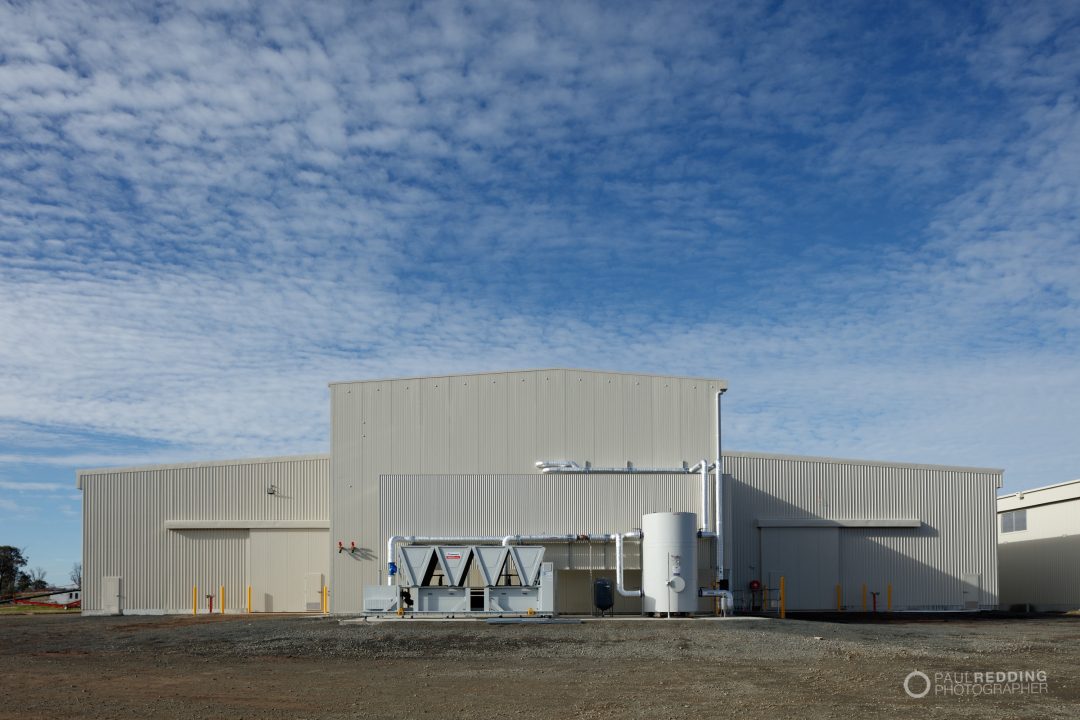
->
997;479;1080;611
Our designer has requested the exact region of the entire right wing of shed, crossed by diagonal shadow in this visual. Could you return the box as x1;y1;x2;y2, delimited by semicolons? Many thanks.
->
724;453;1002;611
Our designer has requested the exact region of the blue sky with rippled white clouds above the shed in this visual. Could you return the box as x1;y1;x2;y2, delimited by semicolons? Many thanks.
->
0;1;1080;581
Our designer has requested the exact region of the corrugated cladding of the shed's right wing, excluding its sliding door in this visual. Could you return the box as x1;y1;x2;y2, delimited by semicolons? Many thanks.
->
725;453;1001;609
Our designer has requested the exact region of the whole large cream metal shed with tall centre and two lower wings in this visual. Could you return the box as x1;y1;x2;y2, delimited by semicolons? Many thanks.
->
79;369;1001;613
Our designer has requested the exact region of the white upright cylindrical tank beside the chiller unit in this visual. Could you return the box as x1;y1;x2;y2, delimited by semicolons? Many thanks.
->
642;513;698;613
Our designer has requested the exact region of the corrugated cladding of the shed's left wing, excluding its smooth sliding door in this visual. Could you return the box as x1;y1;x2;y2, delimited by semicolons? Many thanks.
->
78;456;329;612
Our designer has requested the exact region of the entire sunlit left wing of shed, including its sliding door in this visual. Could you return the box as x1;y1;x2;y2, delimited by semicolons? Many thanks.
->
77;456;330;614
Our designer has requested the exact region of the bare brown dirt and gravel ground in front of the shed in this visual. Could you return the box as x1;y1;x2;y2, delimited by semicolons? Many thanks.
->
0;615;1080;720
